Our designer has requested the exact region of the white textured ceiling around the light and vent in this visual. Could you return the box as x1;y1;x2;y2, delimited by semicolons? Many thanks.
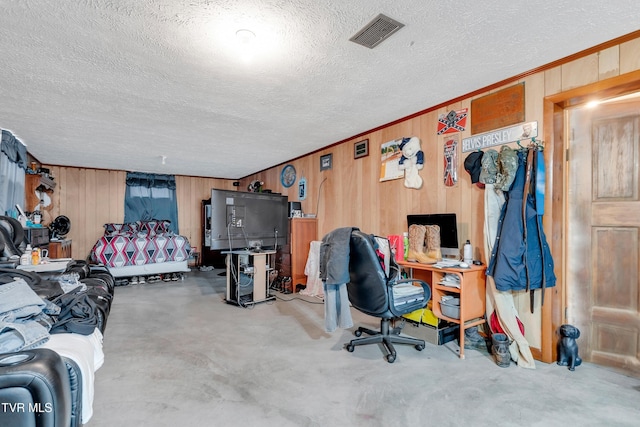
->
0;0;640;179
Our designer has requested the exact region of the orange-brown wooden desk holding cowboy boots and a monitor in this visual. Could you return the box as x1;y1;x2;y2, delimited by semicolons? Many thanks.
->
398;261;486;359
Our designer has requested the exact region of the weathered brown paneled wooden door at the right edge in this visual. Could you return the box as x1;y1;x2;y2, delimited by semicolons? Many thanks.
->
566;97;640;376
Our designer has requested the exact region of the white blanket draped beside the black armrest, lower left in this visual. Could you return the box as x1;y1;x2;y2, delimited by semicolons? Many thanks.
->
41;328;104;424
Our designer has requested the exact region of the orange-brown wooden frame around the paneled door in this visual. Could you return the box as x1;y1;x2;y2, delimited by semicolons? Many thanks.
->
536;70;640;363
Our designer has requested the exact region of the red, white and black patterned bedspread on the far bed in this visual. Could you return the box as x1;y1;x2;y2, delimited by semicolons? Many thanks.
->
91;224;191;267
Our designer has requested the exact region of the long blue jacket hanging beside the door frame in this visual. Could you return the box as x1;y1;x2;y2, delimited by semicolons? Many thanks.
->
487;152;556;300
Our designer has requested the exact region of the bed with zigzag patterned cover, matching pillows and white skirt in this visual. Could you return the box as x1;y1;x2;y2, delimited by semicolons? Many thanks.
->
90;220;191;278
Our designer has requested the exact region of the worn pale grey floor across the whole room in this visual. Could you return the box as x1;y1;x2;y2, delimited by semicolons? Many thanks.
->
88;270;640;427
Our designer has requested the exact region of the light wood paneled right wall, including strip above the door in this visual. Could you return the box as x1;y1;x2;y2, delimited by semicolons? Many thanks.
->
241;38;640;249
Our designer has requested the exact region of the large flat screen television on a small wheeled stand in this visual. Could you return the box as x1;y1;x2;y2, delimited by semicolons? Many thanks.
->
208;188;289;250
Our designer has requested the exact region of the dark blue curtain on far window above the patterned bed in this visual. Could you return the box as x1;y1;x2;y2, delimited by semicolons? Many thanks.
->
124;172;178;234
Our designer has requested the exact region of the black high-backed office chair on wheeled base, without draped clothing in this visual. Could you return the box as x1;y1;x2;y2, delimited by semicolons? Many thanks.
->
346;230;431;363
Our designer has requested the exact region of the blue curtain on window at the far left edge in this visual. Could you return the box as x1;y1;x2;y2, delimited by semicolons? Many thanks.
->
0;129;27;217
